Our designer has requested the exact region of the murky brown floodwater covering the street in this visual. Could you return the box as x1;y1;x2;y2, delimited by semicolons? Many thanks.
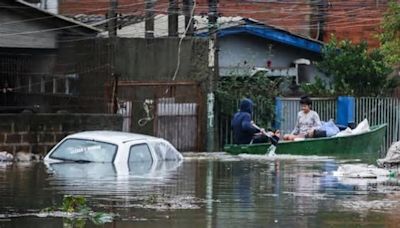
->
0;153;400;227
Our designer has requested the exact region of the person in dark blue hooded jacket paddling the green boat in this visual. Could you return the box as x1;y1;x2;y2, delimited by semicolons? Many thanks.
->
231;98;279;145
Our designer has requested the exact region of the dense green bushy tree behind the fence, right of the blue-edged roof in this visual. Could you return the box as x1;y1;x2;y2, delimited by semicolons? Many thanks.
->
302;38;396;96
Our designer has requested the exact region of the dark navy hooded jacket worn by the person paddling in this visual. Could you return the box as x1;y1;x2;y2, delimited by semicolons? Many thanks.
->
231;98;260;144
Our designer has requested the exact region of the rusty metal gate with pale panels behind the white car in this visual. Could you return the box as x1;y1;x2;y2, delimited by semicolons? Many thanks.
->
106;80;205;151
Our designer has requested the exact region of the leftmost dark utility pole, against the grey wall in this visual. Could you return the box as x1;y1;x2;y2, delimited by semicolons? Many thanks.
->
107;0;118;113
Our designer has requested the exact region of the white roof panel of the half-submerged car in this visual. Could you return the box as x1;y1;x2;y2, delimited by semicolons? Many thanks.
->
67;131;160;144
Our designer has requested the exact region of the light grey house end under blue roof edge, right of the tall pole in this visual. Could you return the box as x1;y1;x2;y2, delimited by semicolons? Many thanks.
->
205;19;323;84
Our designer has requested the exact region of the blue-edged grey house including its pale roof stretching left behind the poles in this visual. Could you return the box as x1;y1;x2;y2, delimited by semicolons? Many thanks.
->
112;15;323;84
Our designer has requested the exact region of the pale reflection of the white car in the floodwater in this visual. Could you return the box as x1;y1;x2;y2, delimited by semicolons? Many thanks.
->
47;161;182;195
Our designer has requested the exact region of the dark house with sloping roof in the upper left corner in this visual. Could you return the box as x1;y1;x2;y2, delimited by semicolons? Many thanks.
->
0;0;106;112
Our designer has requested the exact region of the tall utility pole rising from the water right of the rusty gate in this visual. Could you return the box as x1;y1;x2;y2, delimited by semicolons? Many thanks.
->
207;0;219;151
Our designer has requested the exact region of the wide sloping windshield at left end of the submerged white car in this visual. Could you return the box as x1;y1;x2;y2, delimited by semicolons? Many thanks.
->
50;139;118;162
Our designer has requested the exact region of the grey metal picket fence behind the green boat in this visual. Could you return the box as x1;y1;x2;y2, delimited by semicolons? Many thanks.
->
219;97;400;155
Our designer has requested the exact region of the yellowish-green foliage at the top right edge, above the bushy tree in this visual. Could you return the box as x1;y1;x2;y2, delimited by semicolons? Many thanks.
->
379;1;400;66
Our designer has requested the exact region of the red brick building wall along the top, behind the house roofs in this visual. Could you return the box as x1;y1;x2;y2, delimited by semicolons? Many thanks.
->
60;0;396;47
